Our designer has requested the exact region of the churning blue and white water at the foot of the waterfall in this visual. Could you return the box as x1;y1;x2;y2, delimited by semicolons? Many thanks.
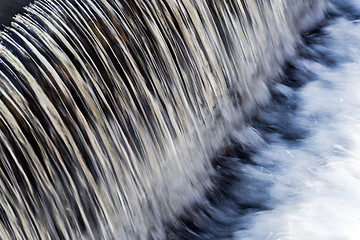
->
173;1;360;240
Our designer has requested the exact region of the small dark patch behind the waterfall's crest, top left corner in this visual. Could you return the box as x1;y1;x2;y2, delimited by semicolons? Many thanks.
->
0;0;33;29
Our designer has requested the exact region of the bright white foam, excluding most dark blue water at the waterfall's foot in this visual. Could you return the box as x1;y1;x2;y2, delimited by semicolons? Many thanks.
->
235;1;360;240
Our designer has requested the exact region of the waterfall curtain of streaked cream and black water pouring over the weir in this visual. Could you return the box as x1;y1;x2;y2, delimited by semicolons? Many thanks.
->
0;0;326;239
